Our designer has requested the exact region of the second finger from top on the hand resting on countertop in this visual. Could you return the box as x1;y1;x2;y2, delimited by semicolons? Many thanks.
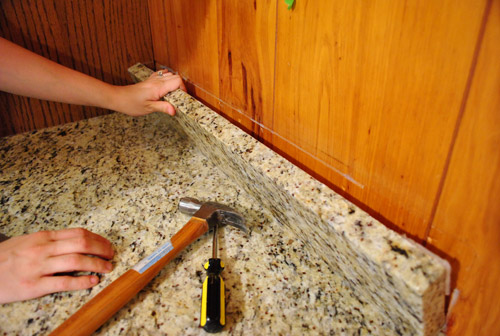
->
49;235;114;259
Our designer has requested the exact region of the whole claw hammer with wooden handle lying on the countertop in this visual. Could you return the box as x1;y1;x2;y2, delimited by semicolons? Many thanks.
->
50;198;247;336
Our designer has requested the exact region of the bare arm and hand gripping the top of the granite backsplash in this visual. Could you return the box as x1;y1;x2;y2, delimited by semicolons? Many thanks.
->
0;37;185;116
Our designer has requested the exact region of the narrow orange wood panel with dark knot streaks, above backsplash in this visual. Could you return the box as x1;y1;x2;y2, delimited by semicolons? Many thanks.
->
217;0;276;138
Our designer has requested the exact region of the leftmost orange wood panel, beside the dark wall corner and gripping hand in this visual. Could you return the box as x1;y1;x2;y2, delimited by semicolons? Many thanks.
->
158;0;240;129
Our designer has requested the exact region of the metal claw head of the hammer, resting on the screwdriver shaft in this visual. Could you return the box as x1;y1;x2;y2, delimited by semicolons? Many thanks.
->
179;197;247;232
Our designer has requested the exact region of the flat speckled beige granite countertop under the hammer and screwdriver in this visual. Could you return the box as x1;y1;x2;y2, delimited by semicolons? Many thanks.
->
0;114;390;335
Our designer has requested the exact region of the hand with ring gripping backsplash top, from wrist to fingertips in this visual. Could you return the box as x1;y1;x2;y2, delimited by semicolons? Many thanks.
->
110;71;186;116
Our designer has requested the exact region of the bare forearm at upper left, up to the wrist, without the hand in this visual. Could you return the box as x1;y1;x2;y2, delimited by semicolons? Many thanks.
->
0;38;116;109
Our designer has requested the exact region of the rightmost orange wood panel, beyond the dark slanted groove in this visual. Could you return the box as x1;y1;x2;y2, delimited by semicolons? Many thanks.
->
428;1;500;335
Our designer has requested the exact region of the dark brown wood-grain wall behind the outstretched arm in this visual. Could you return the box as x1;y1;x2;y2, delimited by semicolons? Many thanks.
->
0;0;153;136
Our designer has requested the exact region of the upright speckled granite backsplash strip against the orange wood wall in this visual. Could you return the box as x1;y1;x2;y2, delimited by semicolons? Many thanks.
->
129;64;449;335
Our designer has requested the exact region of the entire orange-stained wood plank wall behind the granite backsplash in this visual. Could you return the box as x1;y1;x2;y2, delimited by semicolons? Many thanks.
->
149;0;500;335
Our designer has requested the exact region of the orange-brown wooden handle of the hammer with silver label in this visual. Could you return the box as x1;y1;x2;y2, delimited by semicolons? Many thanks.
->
50;217;208;335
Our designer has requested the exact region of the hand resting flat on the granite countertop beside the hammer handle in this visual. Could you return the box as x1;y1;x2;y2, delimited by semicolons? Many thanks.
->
0;229;114;304
